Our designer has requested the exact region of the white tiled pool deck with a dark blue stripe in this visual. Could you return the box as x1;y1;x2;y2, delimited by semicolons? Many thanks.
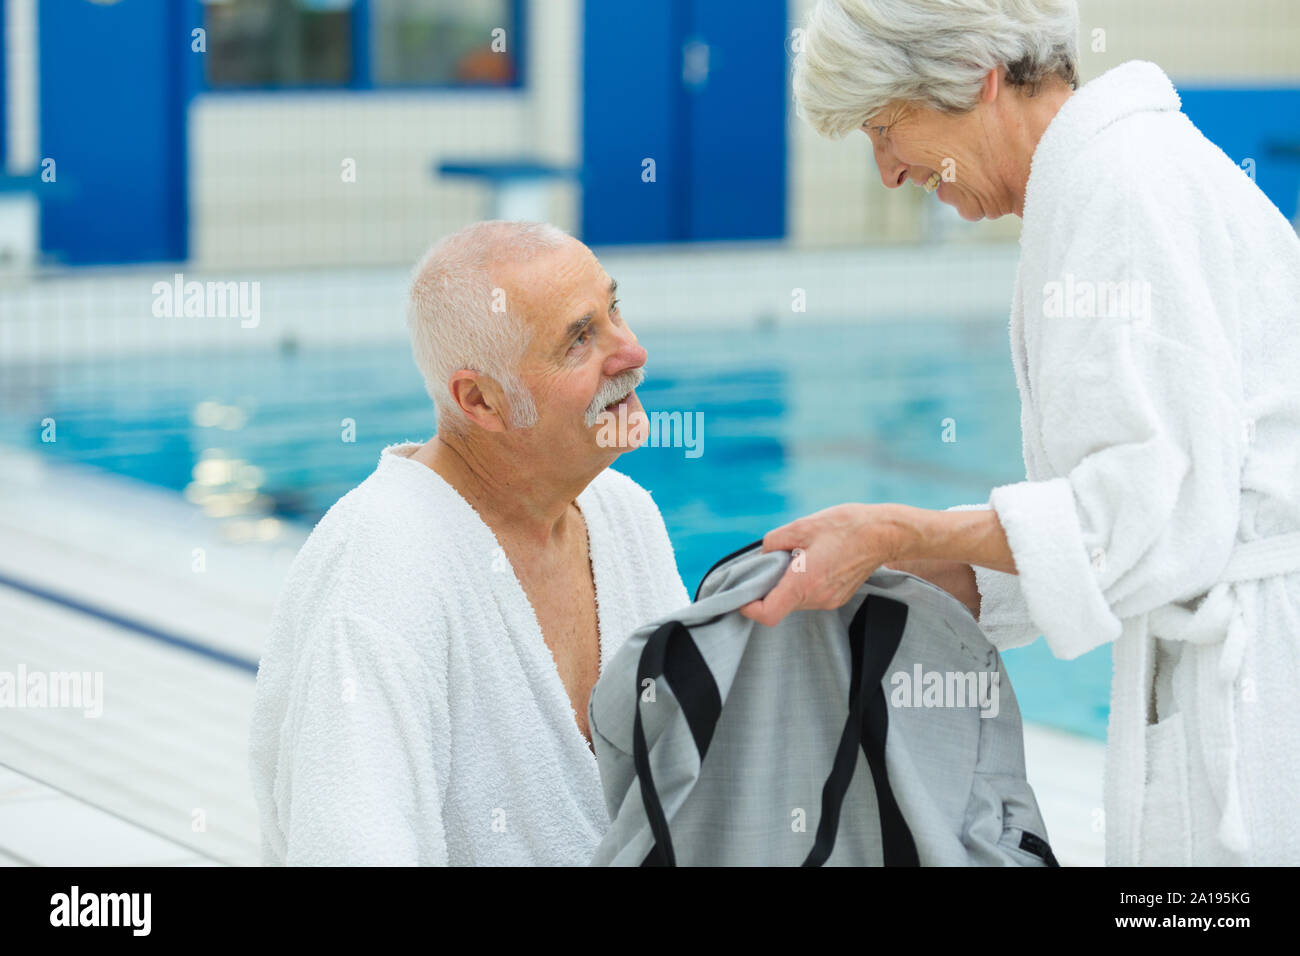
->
0;450;1104;866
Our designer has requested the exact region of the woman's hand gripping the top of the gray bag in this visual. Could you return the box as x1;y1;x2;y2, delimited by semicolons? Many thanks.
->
740;505;918;627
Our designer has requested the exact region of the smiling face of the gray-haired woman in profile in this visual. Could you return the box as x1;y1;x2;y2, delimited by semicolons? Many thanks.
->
862;103;1015;221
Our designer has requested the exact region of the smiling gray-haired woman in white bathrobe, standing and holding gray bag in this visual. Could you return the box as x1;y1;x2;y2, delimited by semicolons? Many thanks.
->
744;0;1300;865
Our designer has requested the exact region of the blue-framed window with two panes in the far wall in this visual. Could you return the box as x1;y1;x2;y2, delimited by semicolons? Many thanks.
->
204;0;523;90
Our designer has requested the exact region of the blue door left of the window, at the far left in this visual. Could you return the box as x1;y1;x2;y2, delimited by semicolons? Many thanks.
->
38;0;188;265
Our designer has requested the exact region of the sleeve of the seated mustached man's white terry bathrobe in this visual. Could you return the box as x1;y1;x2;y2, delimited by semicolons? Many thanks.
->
274;615;447;866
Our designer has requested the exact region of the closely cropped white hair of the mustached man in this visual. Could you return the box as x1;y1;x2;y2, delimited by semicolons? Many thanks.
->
407;220;575;432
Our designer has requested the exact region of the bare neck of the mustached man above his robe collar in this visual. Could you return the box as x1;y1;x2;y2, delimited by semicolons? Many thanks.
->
411;434;592;549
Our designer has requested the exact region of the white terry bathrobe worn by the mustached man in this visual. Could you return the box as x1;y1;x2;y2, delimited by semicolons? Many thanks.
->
251;444;690;865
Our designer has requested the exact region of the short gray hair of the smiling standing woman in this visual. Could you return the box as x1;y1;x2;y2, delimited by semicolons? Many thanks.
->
793;0;1079;139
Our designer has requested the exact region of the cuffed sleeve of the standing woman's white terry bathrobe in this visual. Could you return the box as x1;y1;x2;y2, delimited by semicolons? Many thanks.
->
989;167;1243;658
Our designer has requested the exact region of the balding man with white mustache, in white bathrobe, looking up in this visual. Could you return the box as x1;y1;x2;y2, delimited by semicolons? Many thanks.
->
251;221;690;865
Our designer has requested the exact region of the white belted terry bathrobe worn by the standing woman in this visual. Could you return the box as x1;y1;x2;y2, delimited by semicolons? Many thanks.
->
976;61;1300;865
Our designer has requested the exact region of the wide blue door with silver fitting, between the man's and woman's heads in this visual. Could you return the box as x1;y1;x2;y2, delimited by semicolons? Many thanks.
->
582;0;788;245
